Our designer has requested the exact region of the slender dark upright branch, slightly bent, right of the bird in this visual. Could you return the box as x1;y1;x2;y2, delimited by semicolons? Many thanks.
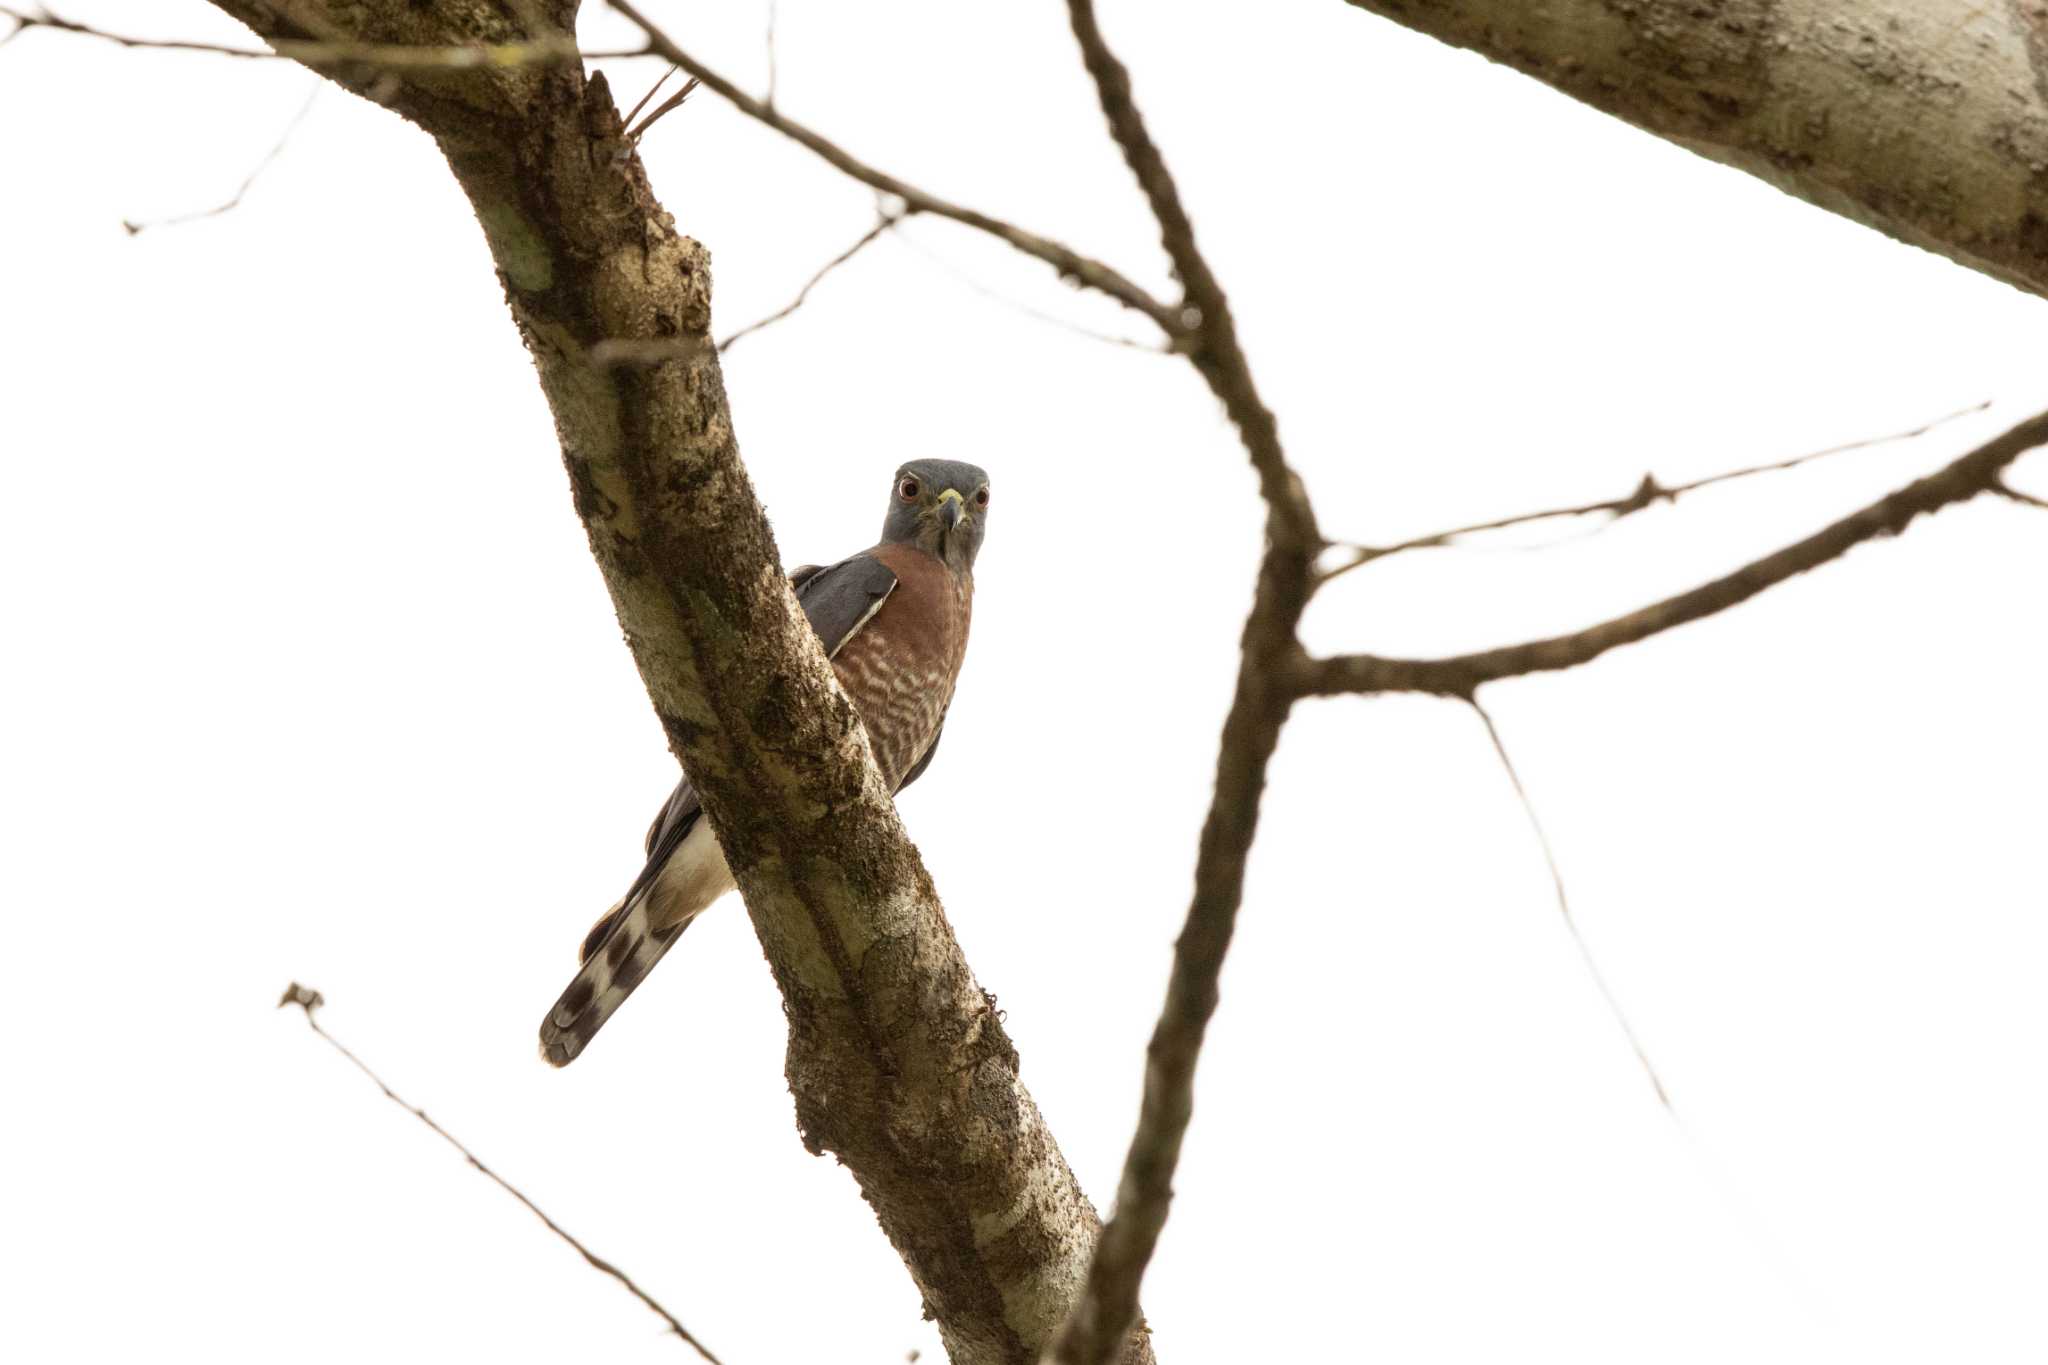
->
1047;0;1323;1365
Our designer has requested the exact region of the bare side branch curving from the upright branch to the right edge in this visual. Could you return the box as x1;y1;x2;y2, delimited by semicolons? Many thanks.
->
1298;413;2048;698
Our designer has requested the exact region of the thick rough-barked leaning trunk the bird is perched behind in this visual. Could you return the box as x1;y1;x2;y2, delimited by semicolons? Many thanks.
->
201;0;1151;1365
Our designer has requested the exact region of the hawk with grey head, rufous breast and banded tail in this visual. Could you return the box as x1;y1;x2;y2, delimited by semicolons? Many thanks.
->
541;460;989;1066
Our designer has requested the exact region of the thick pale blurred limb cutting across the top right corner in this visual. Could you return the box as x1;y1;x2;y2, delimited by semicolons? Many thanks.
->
1350;0;2048;293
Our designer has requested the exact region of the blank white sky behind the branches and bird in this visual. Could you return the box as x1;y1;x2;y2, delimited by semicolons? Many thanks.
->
0;0;2048;1365
